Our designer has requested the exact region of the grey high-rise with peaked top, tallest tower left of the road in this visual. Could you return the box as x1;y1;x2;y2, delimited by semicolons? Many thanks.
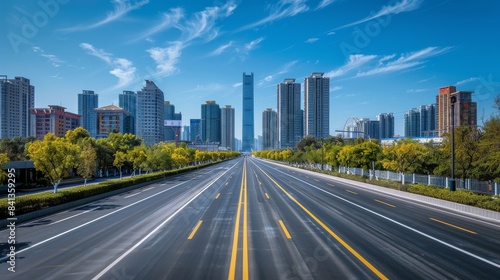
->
135;80;165;145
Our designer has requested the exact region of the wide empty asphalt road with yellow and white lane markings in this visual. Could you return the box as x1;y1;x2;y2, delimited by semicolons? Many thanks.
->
0;157;500;279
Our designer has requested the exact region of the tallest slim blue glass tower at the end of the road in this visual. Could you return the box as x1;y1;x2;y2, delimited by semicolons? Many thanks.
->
242;72;254;152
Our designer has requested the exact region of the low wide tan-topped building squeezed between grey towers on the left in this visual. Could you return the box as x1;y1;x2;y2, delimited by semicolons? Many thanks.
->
94;105;133;139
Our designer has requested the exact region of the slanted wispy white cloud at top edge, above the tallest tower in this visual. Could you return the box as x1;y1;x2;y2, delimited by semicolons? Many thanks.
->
237;0;309;32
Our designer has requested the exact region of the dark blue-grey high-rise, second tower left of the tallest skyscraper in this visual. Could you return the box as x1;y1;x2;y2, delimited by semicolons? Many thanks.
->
201;101;221;144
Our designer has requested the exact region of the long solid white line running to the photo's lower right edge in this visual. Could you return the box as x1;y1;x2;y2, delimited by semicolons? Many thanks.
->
254;158;500;268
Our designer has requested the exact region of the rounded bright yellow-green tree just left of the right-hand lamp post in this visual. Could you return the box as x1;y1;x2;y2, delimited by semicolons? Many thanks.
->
382;138;429;173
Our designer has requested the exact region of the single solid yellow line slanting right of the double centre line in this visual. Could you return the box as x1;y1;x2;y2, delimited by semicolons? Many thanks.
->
252;166;389;280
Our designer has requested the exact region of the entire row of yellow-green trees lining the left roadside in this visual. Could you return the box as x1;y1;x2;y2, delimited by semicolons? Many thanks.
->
0;127;239;192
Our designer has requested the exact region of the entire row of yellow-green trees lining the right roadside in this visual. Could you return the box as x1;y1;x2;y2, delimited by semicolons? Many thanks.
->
254;116;500;181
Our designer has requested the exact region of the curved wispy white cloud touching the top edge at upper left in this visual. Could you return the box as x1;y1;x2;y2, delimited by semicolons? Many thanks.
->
60;0;149;32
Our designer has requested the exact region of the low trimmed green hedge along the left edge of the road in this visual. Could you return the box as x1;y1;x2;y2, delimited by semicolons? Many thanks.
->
0;164;210;219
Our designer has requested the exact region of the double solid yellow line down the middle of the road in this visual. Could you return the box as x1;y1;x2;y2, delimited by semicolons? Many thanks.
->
228;159;248;280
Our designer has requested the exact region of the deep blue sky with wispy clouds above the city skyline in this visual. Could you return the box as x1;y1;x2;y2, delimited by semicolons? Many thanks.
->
0;0;500;138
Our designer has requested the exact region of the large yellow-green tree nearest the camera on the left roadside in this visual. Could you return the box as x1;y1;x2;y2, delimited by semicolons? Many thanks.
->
28;133;80;193
